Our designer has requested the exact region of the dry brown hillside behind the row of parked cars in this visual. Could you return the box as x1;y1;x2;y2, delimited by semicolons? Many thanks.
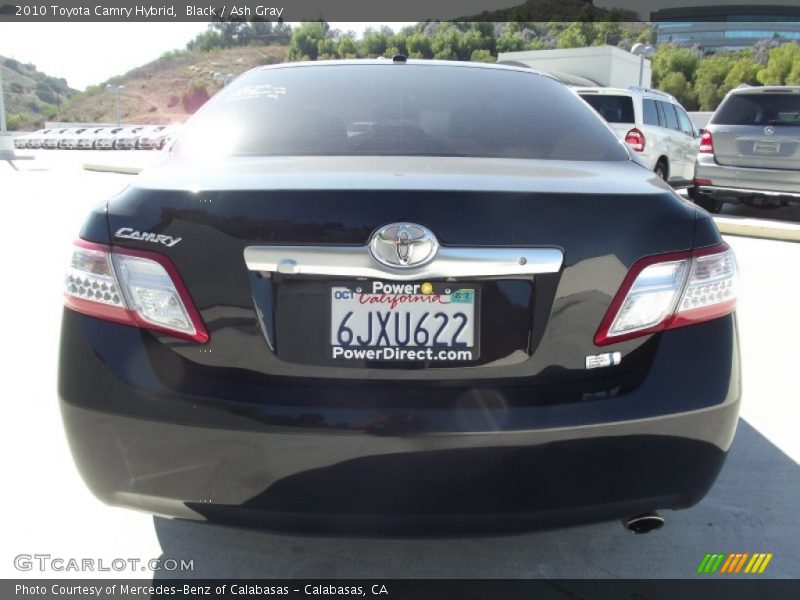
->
3;46;286;130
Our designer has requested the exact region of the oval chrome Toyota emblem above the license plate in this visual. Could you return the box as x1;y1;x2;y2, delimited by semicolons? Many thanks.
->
369;223;439;269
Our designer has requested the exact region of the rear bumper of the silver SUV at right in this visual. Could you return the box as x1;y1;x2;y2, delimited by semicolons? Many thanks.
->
695;155;800;202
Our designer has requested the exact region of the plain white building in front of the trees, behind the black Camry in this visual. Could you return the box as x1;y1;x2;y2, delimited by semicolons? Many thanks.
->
497;46;650;88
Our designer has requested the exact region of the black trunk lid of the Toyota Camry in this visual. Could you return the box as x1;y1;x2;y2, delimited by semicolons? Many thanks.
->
108;157;696;382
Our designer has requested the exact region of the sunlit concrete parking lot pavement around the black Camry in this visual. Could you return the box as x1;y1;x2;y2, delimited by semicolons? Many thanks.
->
0;152;800;578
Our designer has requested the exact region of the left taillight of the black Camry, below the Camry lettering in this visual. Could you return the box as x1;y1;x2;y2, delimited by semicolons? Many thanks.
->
64;240;208;343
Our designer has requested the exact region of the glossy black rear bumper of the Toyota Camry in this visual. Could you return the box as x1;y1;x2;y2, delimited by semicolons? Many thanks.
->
59;311;741;532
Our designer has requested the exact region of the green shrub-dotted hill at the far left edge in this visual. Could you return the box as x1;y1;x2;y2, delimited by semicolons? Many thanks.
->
0;56;78;129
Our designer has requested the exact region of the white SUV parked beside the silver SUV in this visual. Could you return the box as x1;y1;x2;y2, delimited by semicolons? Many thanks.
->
574;86;700;187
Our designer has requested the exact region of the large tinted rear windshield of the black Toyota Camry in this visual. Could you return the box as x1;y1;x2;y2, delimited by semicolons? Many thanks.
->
173;62;628;161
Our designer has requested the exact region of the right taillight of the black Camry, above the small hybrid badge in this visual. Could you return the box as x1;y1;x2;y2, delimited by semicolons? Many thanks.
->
594;243;736;346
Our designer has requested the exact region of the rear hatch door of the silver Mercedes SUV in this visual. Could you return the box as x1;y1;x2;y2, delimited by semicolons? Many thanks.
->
710;88;800;171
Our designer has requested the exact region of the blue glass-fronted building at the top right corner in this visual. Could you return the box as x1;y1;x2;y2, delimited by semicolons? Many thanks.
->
650;4;800;53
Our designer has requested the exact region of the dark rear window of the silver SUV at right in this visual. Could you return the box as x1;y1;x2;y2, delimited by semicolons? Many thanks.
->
711;93;800;125
